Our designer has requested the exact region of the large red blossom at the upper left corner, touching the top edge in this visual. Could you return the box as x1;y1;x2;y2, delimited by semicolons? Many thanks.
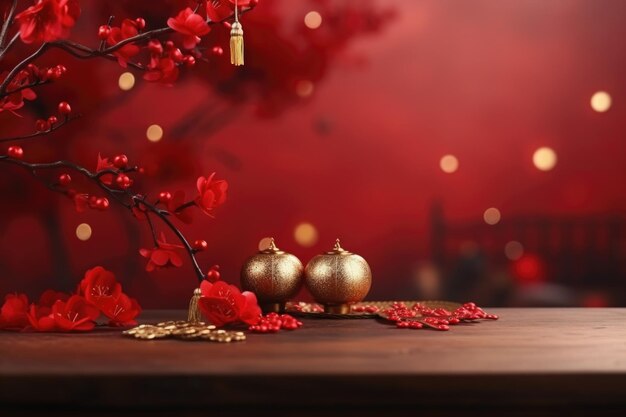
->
15;0;80;43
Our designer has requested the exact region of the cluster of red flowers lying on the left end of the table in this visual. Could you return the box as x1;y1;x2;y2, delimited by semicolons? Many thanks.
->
0;266;141;332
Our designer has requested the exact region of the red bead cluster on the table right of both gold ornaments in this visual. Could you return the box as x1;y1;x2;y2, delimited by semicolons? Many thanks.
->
383;302;498;330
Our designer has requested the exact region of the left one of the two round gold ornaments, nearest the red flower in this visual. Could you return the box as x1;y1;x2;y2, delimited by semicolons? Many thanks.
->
241;238;304;312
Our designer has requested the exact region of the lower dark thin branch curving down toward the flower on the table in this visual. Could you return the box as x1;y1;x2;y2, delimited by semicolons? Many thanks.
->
0;155;205;282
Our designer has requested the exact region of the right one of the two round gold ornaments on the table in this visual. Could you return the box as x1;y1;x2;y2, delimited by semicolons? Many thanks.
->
304;239;372;314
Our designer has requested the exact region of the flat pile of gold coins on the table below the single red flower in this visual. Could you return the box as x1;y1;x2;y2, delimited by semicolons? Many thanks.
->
123;321;246;343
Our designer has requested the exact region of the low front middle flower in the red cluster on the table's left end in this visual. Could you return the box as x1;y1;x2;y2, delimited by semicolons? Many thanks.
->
51;295;100;332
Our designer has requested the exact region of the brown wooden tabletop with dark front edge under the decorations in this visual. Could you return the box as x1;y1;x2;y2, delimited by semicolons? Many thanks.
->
0;308;626;416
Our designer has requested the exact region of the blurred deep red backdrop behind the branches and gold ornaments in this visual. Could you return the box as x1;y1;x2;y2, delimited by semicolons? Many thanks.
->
0;0;626;307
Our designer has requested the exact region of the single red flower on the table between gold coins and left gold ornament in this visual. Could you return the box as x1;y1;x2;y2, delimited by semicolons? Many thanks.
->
198;280;261;326
